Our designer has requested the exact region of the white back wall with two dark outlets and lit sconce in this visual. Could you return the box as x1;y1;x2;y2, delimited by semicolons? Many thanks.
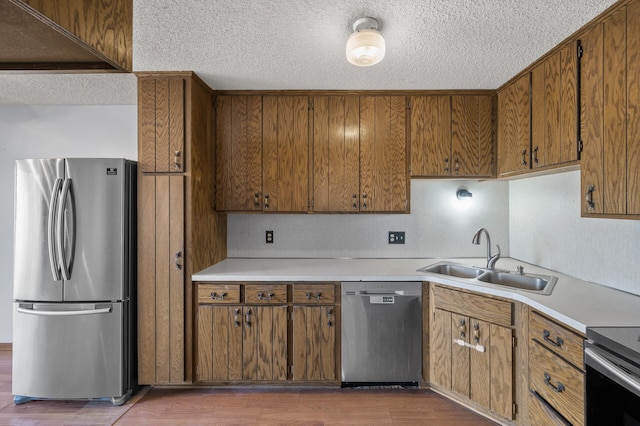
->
227;180;509;258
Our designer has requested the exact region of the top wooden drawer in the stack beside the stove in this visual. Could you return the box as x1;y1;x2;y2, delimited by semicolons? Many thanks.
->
529;311;584;369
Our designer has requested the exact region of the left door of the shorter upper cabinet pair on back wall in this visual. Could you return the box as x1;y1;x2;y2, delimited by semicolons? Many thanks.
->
411;96;452;176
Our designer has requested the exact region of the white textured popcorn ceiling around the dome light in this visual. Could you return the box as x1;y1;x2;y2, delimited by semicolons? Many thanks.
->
0;0;614;104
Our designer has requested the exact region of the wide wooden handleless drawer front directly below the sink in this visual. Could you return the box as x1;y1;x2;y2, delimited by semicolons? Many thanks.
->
433;286;511;327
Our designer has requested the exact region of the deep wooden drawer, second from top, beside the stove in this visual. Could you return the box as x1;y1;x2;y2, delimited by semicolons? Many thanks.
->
529;342;584;425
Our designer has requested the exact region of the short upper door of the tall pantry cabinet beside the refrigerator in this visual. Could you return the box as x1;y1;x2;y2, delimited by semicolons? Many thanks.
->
138;77;185;173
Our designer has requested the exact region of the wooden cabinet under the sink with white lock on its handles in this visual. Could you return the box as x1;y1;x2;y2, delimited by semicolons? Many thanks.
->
430;285;514;420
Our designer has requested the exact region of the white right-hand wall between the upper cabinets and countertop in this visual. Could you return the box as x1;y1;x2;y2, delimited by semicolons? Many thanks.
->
509;171;640;294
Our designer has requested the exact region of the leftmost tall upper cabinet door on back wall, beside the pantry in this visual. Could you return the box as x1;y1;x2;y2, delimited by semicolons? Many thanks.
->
216;96;262;211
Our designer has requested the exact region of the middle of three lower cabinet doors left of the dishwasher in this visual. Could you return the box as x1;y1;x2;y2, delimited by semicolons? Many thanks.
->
242;306;287;381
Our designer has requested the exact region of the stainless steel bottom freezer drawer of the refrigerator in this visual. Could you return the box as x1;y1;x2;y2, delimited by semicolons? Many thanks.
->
13;302;130;403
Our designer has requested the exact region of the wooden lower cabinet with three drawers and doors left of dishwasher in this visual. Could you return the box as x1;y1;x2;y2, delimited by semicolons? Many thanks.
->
195;283;339;383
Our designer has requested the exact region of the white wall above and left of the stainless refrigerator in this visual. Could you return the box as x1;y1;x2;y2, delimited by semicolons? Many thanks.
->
0;105;138;342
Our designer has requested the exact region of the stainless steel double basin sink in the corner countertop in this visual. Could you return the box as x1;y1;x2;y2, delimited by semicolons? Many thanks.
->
418;262;558;295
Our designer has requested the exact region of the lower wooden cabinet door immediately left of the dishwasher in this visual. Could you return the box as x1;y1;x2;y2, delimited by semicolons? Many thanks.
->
293;305;336;381
